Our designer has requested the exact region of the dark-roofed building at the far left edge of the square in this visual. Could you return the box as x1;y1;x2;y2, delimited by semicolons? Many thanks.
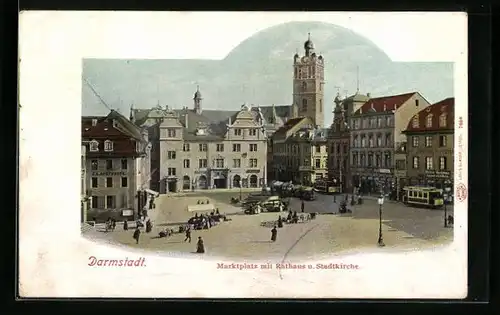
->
82;110;150;216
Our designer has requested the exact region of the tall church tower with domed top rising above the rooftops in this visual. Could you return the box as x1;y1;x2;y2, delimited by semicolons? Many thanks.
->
292;34;325;127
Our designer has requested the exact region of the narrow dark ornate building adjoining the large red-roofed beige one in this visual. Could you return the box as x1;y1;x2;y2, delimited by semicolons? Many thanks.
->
327;95;352;192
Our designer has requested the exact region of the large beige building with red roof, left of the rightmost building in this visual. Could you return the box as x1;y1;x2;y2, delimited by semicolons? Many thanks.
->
349;92;429;194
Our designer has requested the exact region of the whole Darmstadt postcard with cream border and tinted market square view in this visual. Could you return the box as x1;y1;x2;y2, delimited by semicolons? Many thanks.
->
18;11;468;299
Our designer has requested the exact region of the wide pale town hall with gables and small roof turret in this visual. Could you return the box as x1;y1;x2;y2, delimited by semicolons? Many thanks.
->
131;89;267;193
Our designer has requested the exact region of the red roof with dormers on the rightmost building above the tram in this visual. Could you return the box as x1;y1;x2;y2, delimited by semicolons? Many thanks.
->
405;97;455;132
